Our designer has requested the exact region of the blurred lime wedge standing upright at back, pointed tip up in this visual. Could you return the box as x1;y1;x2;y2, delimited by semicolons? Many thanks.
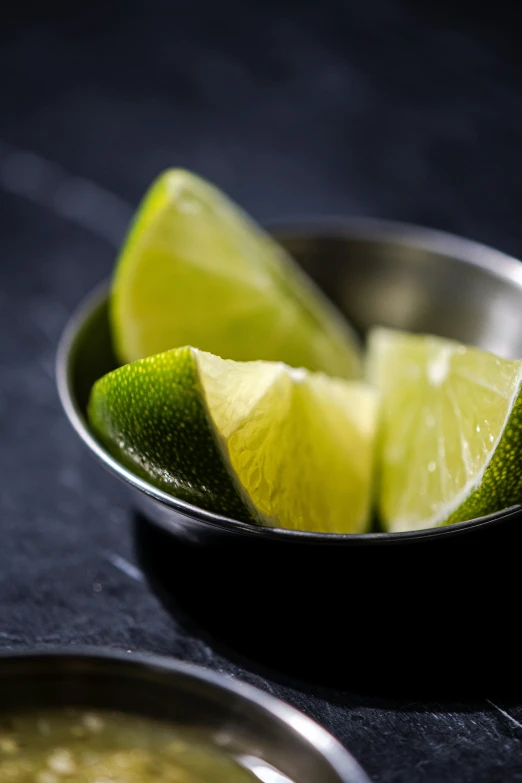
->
111;169;361;378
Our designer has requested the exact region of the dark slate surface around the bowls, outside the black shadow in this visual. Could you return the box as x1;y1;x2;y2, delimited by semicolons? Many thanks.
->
0;0;522;783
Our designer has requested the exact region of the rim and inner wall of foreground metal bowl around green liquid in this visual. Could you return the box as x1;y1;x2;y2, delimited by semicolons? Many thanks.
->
0;648;369;783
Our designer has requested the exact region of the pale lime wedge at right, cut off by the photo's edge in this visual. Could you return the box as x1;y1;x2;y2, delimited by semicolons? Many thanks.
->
367;329;522;531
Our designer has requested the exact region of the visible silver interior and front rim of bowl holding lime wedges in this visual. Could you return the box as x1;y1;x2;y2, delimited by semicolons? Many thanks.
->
57;220;522;543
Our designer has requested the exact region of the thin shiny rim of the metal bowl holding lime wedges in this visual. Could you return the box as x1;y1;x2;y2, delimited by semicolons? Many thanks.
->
55;217;522;545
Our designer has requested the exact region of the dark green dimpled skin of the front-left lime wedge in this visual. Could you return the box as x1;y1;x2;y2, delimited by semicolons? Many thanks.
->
88;348;255;522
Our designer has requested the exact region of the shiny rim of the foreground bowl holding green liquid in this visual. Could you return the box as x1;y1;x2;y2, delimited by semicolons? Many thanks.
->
0;645;370;783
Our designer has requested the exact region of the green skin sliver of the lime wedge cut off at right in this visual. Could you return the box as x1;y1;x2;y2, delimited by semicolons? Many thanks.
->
443;391;522;525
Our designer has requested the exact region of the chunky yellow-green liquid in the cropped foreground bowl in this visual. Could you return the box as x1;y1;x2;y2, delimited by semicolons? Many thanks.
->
0;710;257;783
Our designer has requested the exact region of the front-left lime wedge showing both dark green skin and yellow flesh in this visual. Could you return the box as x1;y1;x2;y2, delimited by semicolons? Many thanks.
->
89;348;376;533
